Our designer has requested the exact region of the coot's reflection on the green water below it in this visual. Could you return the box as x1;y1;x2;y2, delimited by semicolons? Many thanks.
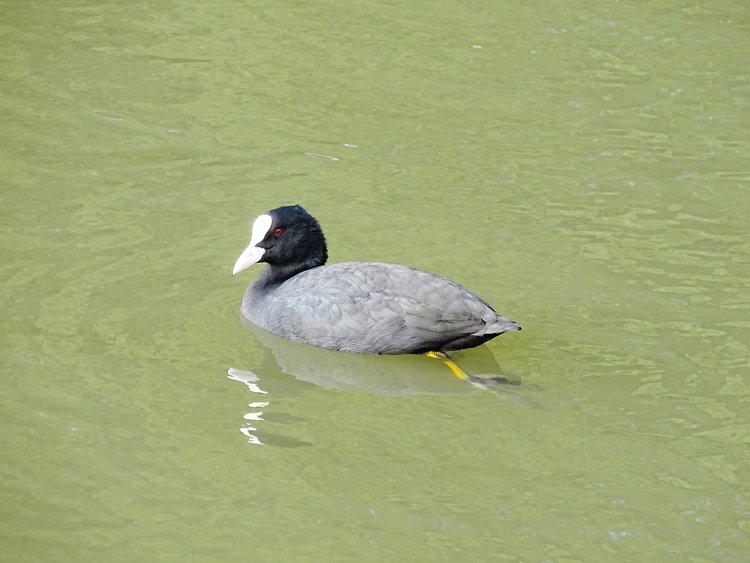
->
228;323;520;447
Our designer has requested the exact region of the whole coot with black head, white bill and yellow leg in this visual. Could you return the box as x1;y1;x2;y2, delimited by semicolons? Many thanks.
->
232;205;521;386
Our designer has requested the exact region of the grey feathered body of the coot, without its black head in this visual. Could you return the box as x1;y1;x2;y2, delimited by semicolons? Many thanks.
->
242;262;521;354
